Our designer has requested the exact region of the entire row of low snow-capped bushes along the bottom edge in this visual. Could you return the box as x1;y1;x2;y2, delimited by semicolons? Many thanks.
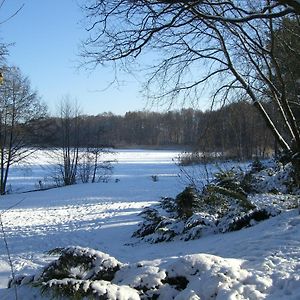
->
10;247;270;300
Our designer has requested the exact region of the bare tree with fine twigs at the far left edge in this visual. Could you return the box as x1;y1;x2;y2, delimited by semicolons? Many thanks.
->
0;67;46;195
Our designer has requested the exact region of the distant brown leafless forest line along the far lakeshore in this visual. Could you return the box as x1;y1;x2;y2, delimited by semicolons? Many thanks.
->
28;102;275;158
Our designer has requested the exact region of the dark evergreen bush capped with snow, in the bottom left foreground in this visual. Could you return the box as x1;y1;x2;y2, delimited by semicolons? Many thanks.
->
9;247;139;299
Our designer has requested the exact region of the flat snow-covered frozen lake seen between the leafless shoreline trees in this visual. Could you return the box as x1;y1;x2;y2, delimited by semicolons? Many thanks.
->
8;149;184;193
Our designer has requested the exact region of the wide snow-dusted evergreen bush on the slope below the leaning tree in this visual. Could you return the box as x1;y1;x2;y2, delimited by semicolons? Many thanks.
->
133;161;297;243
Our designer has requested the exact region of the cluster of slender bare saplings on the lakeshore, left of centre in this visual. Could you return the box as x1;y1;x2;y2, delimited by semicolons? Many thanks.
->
50;96;113;185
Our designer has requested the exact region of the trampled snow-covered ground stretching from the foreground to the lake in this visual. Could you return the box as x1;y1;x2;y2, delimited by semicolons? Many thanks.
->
0;150;300;300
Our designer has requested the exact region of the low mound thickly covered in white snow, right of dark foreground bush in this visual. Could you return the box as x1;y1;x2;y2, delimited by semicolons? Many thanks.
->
114;254;272;300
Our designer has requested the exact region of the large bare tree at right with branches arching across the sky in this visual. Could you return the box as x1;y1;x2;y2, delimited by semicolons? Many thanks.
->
83;0;300;162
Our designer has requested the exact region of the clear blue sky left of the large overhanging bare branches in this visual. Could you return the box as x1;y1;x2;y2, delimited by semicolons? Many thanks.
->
0;0;146;115
